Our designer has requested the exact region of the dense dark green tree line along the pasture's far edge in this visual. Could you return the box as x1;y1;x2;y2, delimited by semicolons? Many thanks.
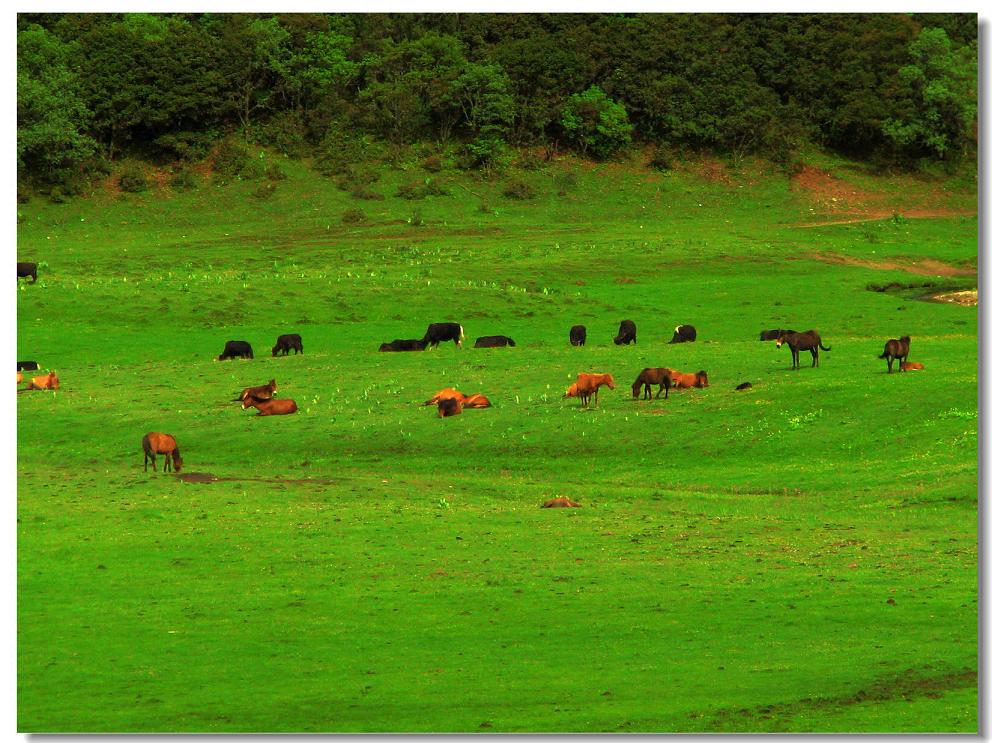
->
17;13;978;187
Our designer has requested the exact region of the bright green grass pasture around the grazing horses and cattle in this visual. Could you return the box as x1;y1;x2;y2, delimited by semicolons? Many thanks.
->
17;151;978;733
